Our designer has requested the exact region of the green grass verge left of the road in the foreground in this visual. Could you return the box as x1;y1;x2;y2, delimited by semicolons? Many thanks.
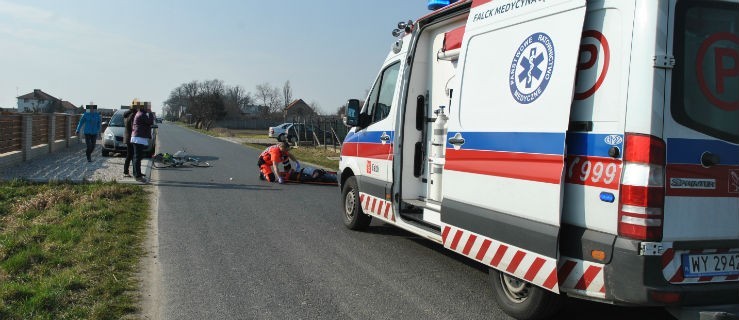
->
0;181;149;319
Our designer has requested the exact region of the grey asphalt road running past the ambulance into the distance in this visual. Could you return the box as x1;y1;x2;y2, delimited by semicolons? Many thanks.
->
152;123;670;320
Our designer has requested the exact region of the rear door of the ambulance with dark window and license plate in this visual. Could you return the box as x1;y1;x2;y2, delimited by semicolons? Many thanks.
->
662;1;739;284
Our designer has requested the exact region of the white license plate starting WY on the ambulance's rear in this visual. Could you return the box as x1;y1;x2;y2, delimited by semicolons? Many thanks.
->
683;252;739;277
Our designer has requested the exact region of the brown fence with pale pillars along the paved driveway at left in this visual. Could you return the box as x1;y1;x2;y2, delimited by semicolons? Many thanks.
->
0;113;82;168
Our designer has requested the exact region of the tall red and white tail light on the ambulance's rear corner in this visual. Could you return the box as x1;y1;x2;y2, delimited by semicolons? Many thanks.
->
618;133;666;241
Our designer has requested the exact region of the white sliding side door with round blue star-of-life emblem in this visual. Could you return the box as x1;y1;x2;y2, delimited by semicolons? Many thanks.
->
441;0;586;292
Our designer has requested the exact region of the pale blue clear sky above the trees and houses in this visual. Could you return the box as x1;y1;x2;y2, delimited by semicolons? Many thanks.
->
0;0;430;114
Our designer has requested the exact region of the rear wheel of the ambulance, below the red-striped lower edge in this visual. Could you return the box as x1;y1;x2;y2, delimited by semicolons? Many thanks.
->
489;268;564;320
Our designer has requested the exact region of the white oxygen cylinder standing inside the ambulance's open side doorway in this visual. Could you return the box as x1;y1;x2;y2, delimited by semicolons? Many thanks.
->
428;106;449;202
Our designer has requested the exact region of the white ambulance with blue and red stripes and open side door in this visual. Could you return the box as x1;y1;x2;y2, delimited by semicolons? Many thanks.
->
339;0;739;319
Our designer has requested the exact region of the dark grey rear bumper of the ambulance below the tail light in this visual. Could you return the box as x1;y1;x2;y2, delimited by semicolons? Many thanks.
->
605;238;739;307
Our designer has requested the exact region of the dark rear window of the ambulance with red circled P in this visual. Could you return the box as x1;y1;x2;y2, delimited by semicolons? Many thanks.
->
672;1;739;143
